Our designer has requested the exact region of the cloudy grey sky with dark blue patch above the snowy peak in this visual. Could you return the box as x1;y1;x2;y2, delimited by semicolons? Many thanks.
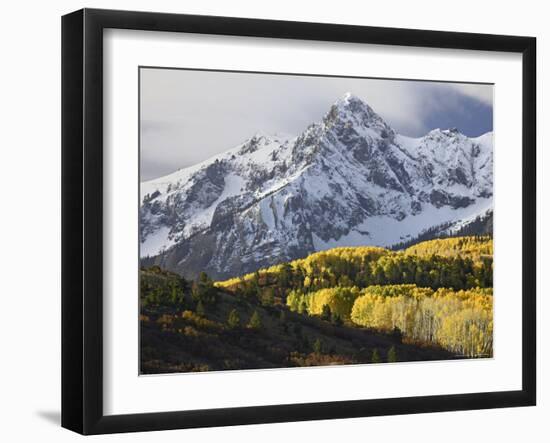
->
140;68;493;181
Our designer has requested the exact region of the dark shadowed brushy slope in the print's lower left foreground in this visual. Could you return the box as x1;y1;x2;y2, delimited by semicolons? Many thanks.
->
140;270;454;374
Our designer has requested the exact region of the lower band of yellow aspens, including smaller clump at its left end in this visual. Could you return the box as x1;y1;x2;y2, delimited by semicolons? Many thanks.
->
287;284;493;357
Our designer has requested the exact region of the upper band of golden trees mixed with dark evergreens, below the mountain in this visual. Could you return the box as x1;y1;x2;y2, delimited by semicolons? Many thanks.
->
216;237;493;301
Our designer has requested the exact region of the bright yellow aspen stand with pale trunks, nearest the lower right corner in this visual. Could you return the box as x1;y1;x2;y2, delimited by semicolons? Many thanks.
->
351;285;493;357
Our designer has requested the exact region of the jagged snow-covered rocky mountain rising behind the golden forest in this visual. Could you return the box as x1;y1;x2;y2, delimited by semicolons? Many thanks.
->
140;93;493;279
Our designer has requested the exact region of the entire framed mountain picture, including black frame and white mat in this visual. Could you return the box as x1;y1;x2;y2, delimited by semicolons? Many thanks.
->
62;9;536;434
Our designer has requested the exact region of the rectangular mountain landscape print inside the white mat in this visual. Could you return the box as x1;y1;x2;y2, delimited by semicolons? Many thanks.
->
139;67;493;374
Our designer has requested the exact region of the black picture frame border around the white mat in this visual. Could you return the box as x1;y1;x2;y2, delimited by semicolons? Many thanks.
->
62;9;536;434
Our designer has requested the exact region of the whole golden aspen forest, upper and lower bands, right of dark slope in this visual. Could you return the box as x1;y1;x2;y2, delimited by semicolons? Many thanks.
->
216;236;493;357
